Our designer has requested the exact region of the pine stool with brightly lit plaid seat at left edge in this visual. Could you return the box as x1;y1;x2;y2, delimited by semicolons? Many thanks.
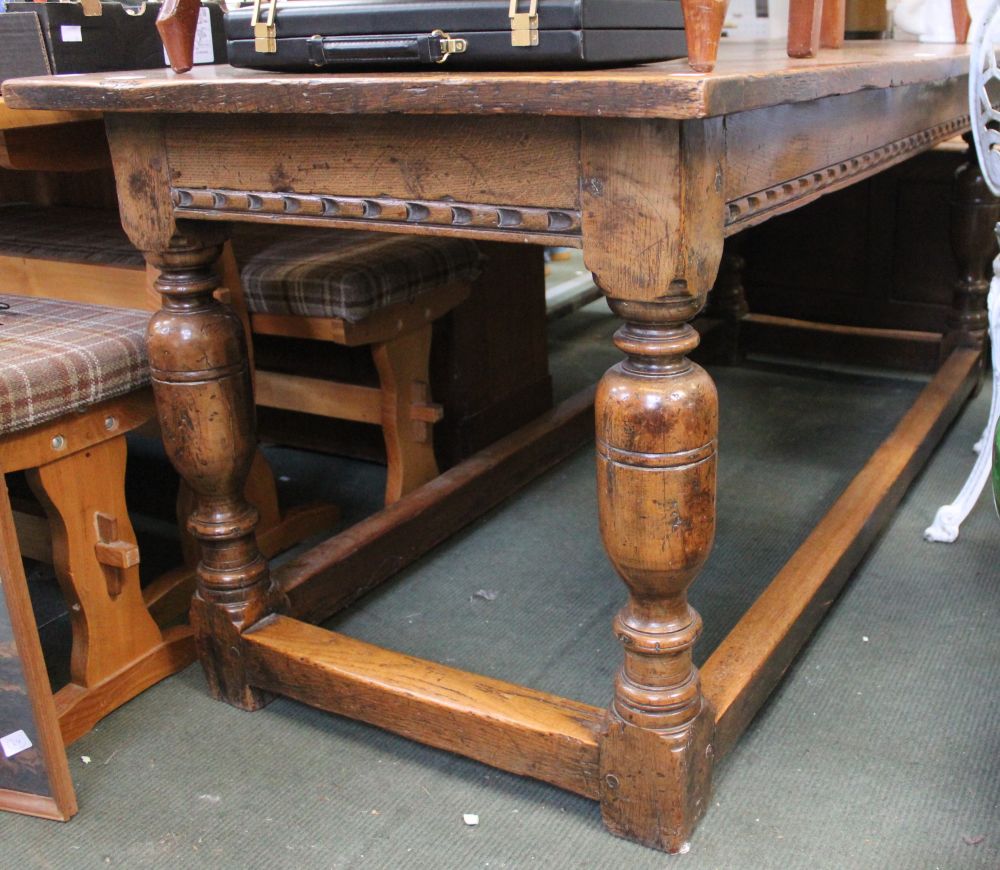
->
0;296;194;743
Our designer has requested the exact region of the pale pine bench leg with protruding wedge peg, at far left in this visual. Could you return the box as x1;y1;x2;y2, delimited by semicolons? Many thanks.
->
28;436;194;742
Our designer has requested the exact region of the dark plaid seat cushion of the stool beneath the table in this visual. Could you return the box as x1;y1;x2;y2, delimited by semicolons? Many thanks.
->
233;227;481;323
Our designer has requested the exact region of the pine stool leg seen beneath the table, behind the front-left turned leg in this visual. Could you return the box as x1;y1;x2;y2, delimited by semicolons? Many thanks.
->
372;323;441;504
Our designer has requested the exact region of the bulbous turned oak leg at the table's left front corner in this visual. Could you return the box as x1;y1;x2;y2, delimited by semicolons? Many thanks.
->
148;238;279;710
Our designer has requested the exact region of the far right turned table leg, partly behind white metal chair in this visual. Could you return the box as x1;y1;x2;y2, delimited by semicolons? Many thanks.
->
945;133;1000;352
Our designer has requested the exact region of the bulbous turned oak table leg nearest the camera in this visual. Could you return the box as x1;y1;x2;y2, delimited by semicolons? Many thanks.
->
596;299;718;852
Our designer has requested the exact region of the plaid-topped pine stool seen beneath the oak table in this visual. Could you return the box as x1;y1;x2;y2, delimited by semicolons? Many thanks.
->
234;228;481;504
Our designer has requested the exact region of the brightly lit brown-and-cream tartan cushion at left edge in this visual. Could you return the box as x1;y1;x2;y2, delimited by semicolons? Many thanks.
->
0;295;150;434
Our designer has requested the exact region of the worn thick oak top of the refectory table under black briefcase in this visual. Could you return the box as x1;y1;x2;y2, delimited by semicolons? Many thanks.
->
3;41;969;119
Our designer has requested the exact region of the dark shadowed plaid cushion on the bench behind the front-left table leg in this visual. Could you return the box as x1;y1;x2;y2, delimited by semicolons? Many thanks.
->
0;203;145;269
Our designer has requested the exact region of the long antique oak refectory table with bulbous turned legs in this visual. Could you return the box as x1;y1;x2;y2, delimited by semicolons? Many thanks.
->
3;43;995;851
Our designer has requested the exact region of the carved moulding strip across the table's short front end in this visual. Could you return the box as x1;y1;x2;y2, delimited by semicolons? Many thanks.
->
171;187;580;237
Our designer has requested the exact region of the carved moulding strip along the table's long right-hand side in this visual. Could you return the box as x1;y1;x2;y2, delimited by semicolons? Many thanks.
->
726;115;969;235
